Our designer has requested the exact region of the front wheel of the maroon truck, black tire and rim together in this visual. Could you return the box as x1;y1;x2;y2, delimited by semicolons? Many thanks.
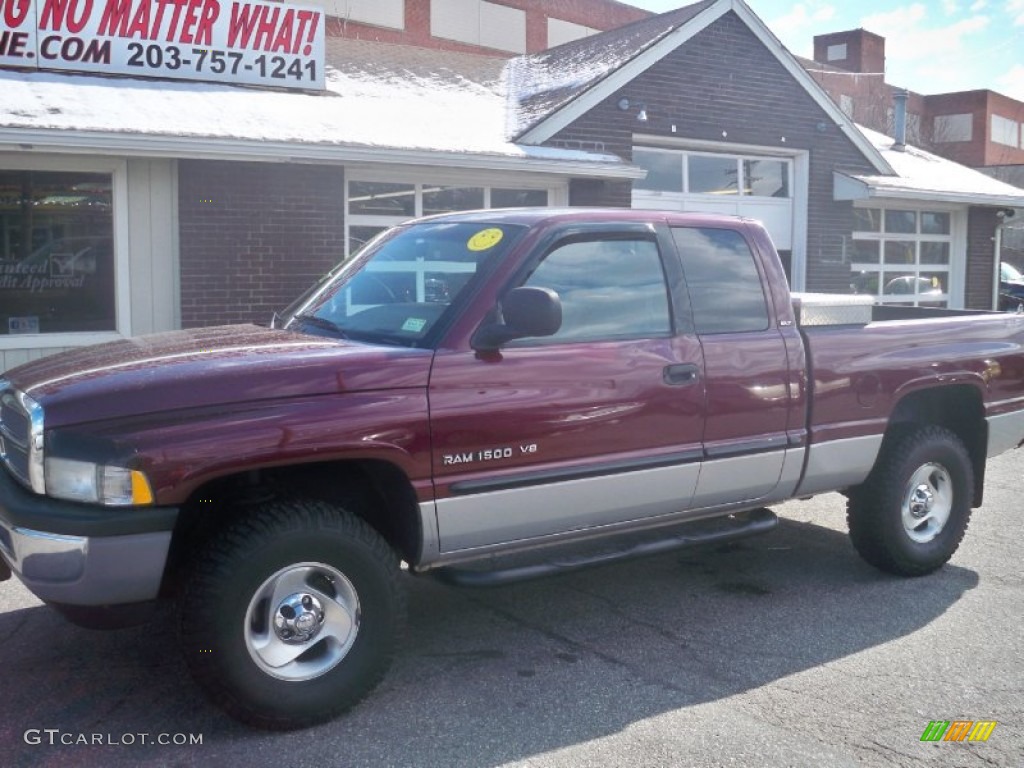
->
178;501;406;730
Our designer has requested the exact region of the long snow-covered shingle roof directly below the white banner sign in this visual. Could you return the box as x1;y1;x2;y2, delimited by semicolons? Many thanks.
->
0;38;625;174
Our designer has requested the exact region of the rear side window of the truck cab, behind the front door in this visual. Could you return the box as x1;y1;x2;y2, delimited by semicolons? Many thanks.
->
672;227;768;334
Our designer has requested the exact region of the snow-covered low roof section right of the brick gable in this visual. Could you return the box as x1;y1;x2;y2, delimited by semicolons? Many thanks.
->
838;125;1024;208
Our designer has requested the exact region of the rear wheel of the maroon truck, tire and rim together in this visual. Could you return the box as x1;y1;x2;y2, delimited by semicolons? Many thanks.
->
847;426;974;577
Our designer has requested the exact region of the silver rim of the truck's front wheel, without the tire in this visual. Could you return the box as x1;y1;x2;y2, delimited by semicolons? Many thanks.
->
245;562;359;681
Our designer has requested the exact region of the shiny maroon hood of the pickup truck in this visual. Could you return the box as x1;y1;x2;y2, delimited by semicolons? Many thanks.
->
4;326;433;428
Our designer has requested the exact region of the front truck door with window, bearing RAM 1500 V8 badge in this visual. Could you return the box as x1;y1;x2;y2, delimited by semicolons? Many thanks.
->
429;225;705;553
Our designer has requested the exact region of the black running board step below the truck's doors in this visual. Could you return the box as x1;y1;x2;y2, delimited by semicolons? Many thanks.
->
426;509;778;587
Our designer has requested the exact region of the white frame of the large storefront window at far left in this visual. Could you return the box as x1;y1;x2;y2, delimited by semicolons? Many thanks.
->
0;153;131;351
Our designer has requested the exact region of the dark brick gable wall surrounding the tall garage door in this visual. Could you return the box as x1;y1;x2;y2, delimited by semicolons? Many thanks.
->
548;13;874;293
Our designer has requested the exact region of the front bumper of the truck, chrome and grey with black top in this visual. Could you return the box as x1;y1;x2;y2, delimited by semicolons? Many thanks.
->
0;470;178;606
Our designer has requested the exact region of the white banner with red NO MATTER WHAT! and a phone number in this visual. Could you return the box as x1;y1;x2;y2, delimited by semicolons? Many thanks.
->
0;0;325;89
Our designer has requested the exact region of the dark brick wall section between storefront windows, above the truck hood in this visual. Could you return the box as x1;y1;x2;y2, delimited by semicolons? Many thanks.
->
178;160;344;328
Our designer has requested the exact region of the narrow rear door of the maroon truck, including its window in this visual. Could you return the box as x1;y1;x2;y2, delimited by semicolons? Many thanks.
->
672;227;803;508
